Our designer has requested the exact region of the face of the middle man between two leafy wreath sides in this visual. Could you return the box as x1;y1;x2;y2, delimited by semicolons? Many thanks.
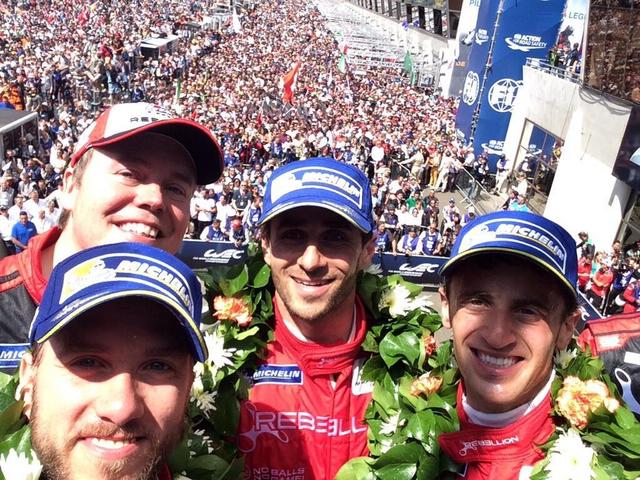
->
262;207;375;323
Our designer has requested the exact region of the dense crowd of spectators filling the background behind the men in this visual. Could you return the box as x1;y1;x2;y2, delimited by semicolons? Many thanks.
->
0;0;640;316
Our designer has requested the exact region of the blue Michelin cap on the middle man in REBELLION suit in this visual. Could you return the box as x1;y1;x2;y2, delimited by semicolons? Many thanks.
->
259;158;375;233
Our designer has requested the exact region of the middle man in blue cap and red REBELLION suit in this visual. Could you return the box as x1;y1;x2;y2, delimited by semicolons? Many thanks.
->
238;158;375;479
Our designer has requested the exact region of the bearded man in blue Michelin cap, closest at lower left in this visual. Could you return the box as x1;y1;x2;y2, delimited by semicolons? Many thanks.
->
19;243;207;480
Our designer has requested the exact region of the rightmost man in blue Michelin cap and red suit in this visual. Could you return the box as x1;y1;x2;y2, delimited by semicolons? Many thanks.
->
439;212;579;480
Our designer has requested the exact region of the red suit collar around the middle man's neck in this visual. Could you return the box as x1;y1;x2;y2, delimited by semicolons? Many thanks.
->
273;296;367;377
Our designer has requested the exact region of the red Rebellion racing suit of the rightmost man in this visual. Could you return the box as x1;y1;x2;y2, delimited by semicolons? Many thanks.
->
438;382;555;480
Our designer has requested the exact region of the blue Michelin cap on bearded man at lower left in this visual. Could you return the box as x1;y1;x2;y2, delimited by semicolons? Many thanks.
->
29;243;208;362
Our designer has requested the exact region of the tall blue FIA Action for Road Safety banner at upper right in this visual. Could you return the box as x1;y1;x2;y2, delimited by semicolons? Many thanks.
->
456;0;565;166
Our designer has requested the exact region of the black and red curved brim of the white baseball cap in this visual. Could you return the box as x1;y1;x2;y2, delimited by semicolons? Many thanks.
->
71;118;224;185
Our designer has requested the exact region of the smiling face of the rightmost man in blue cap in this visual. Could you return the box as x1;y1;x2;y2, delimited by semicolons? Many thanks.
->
441;258;576;413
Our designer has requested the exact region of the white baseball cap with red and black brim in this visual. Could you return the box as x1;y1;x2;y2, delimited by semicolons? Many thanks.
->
70;102;224;185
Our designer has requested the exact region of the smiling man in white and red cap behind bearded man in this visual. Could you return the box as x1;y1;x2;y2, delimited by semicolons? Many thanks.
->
0;103;223;373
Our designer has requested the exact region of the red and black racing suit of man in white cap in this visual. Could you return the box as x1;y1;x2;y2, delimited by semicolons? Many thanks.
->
0;227;61;374
